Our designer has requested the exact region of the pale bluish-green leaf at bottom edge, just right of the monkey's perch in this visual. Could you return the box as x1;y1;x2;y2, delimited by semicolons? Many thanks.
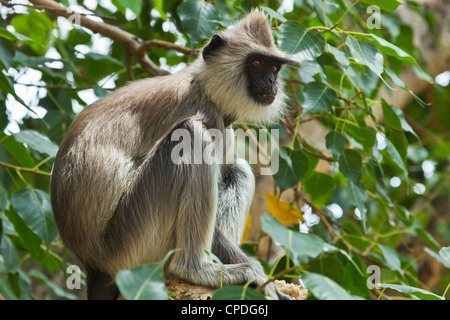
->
302;273;355;300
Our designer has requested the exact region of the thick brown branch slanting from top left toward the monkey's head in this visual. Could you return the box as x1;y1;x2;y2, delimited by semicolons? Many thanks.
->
29;0;170;76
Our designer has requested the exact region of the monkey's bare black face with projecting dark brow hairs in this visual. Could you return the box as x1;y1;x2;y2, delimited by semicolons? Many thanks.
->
245;53;295;105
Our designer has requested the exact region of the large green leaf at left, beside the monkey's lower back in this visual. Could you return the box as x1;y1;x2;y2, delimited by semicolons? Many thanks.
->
11;188;58;245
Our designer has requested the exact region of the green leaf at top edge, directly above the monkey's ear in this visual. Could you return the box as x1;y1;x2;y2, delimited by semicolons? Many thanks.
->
177;0;220;45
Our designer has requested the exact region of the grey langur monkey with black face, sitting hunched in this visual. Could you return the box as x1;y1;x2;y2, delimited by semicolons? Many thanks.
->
51;9;296;299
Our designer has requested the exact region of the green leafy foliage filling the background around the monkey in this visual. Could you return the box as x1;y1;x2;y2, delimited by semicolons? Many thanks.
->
0;0;450;299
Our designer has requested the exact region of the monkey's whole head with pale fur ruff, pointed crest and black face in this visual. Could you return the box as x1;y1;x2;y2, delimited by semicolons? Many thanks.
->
197;10;297;122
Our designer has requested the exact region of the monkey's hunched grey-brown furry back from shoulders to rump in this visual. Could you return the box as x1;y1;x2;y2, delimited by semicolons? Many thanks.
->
51;67;214;265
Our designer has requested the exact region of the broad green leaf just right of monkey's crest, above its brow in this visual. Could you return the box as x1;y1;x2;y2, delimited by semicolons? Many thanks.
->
278;21;325;63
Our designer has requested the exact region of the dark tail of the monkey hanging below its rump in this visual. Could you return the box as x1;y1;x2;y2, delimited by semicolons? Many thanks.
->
86;267;119;300
